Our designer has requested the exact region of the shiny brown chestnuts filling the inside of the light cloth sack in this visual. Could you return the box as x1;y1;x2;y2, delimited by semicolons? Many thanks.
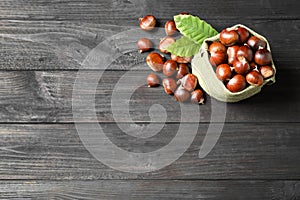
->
208;27;275;93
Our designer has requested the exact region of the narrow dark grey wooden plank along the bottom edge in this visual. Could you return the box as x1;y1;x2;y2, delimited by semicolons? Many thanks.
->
0;180;300;200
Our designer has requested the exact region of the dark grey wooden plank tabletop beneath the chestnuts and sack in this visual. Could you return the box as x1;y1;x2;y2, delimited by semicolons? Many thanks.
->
0;0;300;200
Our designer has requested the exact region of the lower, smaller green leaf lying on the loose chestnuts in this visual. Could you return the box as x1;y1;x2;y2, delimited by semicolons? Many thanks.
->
167;36;201;57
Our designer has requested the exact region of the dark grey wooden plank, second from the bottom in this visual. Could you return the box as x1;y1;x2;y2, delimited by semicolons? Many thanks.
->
0;123;300;180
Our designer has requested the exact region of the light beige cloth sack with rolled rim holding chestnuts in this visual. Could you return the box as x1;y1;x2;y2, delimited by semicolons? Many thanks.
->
191;24;276;102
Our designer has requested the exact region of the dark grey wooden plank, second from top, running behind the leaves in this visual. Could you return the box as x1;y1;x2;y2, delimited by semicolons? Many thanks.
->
0;19;300;70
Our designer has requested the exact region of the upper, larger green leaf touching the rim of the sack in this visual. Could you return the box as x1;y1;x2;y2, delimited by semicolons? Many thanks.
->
174;15;218;45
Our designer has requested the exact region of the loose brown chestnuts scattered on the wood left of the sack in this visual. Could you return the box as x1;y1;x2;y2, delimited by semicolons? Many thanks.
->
137;13;204;104
